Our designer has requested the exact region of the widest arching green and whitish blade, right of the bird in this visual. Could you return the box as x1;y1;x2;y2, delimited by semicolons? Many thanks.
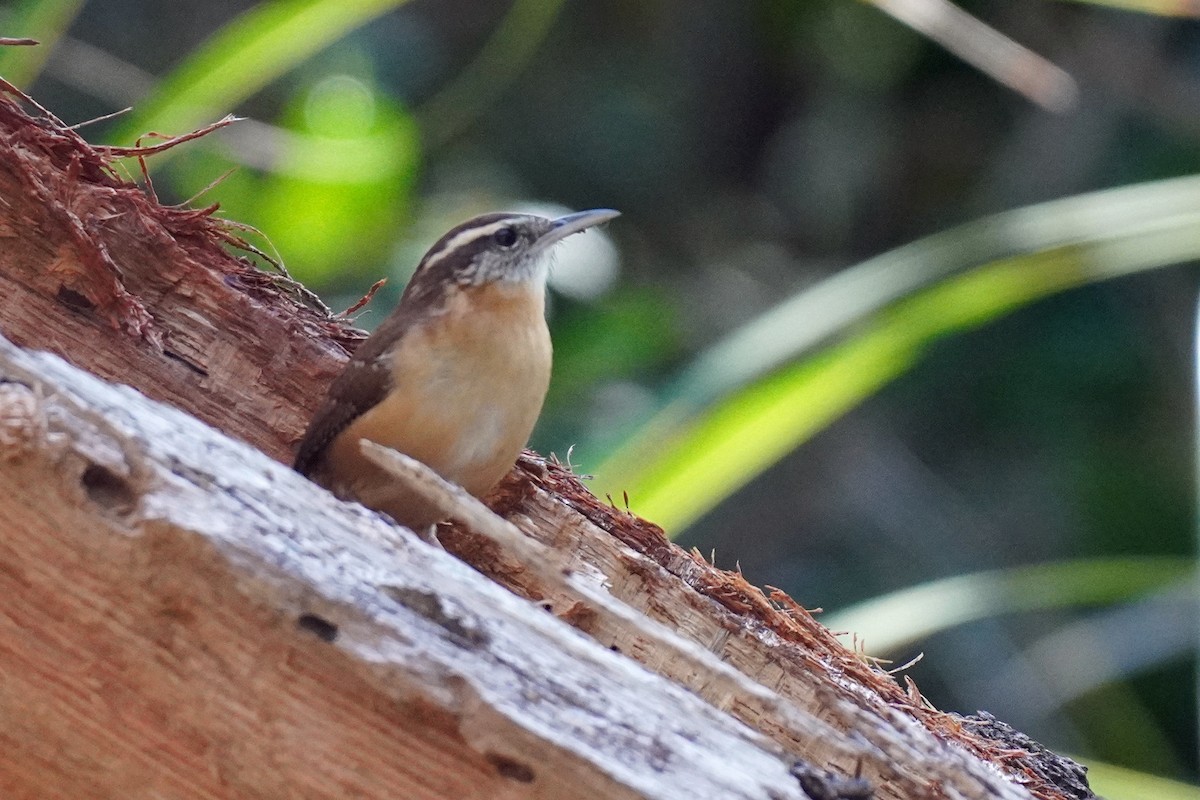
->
584;178;1200;531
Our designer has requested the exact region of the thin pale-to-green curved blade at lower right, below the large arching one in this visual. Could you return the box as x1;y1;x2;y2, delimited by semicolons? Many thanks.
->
821;557;1195;655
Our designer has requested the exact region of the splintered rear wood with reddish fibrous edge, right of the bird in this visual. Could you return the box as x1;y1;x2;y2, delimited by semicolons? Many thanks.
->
362;443;1056;800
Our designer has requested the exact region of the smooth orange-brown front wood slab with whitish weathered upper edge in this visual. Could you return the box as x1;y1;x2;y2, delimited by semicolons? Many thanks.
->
0;342;816;799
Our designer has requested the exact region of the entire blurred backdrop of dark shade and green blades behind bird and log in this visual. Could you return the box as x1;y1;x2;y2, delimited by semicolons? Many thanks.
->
0;0;1200;799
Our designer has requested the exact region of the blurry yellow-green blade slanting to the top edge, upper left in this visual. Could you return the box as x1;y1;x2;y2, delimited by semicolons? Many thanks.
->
115;0;407;142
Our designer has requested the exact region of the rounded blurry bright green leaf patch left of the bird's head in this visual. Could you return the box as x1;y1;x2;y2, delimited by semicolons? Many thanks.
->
168;74;421;288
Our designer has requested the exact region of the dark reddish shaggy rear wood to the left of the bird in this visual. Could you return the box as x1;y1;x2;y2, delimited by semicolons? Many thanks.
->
0;87;360;461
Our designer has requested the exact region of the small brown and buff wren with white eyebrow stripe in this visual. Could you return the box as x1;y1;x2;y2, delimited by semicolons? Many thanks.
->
295;209;618;531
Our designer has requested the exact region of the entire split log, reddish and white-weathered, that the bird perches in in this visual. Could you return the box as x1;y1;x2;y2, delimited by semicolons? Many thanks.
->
0;76;1091;800
